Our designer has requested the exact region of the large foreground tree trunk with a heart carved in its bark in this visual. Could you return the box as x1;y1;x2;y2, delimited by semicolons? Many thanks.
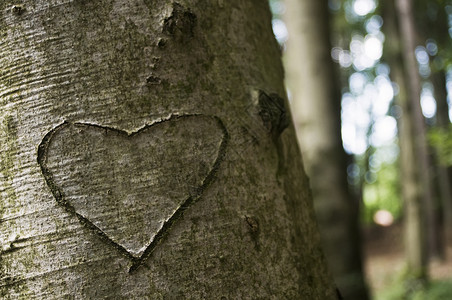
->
0;0;336;300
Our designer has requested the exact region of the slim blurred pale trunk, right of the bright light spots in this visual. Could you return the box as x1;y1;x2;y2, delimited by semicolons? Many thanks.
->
386;0;431;284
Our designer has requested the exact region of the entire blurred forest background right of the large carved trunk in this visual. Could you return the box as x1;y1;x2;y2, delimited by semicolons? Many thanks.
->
270;0;452;300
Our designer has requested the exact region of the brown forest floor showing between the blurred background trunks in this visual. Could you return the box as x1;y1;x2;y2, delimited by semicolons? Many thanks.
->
363;224;452;299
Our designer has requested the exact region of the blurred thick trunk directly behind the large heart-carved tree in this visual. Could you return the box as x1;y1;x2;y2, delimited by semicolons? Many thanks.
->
285;0;368;299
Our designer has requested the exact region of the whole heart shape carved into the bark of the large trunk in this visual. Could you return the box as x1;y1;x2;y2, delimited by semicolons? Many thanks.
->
38;115;228;270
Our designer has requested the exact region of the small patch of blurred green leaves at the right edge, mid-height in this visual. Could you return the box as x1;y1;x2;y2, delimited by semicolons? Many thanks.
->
428;125;452;166
